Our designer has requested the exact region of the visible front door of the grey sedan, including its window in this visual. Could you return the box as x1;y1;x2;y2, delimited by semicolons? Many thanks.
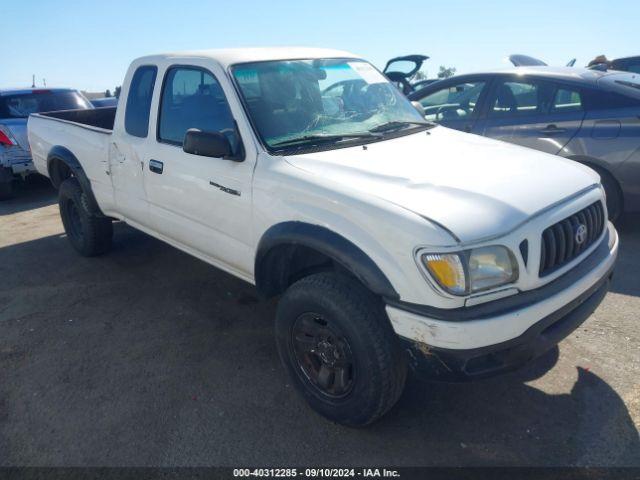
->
410;77;488;133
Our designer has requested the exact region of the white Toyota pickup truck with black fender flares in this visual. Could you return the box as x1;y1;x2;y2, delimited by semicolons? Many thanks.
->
28;48;618;425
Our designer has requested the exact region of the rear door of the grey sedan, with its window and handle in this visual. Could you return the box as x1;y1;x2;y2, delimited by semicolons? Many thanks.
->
480;76;585;154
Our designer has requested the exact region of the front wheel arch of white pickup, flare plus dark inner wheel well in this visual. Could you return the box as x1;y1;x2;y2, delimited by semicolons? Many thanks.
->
254;221;400;299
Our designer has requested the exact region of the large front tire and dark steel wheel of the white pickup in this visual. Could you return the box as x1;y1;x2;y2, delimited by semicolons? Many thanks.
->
275;272;407;426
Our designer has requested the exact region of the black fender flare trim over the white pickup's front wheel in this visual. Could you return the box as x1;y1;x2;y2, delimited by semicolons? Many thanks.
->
254;221;400;299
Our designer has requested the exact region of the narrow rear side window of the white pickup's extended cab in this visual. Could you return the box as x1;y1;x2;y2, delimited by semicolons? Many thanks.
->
124;66;158;138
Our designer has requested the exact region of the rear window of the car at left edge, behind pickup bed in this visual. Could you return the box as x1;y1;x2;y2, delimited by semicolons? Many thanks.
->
0;90;92;118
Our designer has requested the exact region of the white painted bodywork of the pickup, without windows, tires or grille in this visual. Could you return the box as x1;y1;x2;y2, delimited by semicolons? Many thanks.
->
28;48;615;354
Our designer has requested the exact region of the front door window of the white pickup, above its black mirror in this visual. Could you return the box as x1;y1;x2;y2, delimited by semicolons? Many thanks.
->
158;67;239;153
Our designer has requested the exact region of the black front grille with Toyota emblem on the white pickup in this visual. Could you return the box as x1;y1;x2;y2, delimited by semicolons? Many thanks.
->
539;202;605;277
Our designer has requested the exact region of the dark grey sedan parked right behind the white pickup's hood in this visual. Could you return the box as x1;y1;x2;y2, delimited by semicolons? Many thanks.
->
409;66;640;219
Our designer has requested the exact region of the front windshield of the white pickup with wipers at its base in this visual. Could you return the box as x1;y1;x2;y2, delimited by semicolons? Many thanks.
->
232;59;430;150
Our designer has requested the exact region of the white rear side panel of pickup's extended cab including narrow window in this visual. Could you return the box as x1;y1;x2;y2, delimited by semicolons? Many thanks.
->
109;65;158;226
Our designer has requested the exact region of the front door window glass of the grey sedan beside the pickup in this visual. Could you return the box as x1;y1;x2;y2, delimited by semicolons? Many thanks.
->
419;82;485;122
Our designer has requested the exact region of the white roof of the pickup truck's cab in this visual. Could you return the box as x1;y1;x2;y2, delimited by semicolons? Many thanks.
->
135;47;359;68
